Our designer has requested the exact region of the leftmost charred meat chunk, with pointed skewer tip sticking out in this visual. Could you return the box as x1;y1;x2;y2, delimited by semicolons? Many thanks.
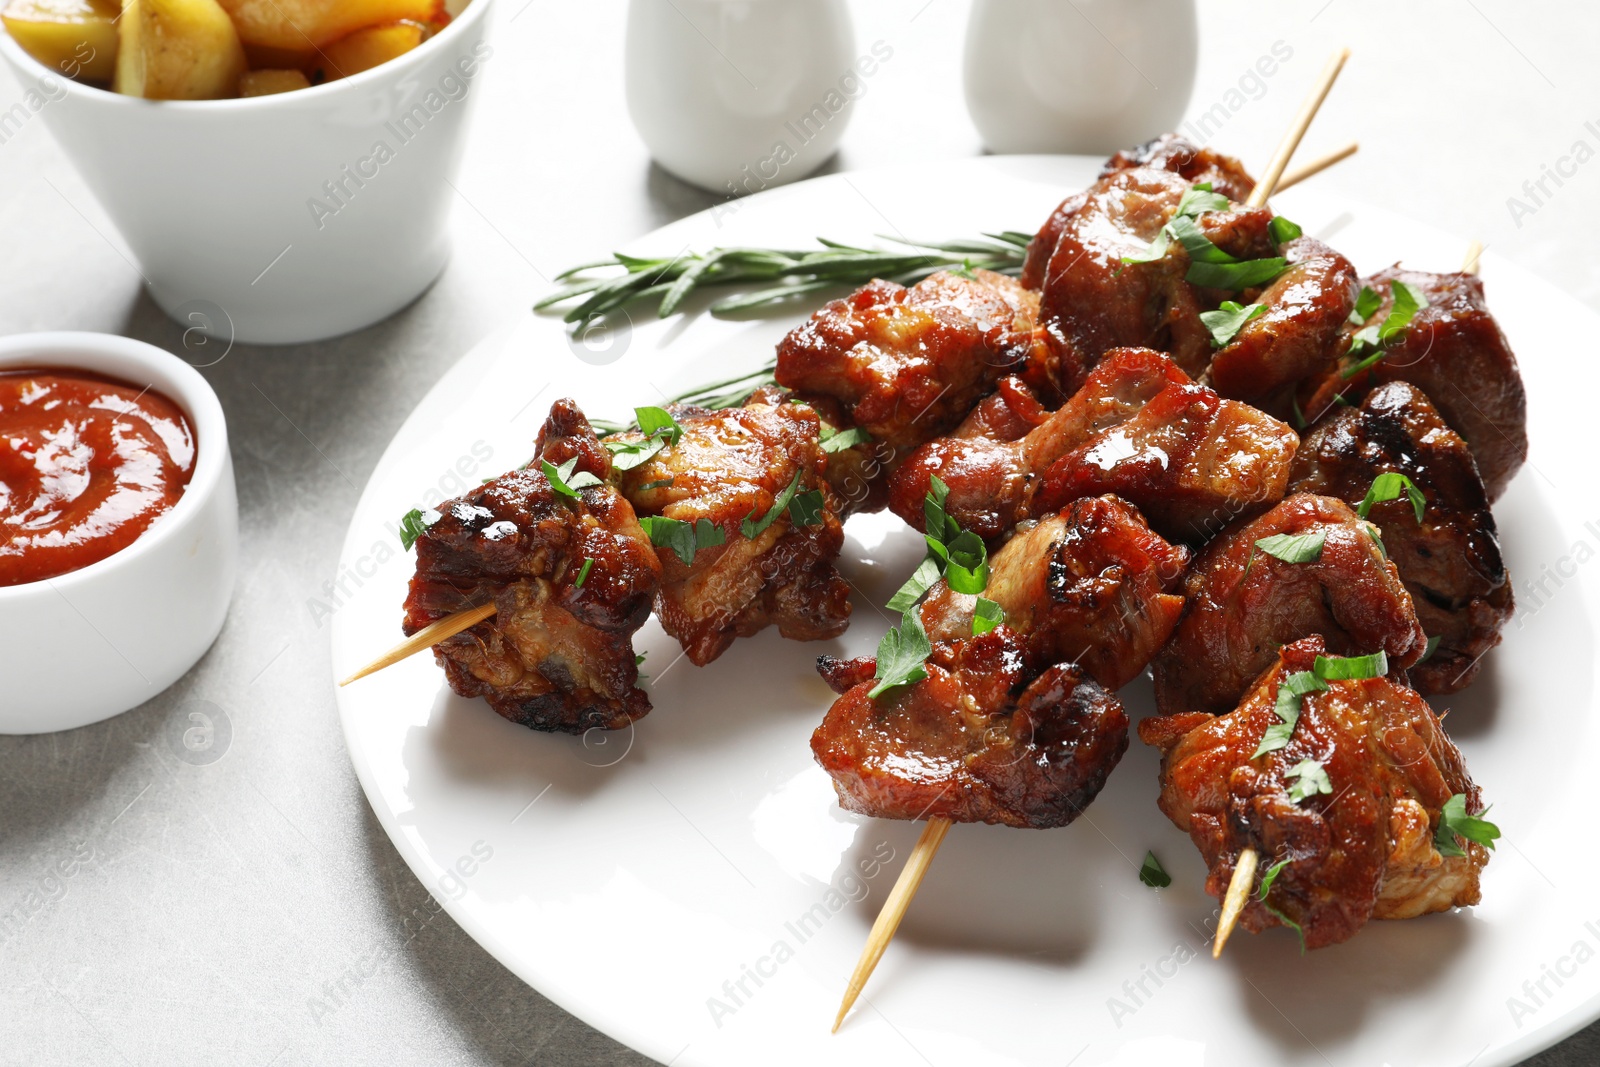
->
405;400;661;733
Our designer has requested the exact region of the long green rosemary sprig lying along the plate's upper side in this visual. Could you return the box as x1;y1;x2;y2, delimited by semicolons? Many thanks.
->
533;230;1032;327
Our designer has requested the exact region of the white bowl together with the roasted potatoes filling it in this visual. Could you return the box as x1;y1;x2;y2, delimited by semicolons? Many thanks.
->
0;0;494;344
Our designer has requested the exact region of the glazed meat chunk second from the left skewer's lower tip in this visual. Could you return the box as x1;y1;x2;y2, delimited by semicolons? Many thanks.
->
614;403;850;665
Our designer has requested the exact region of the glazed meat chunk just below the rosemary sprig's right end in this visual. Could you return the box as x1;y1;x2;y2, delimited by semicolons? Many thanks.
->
778;270;1038;454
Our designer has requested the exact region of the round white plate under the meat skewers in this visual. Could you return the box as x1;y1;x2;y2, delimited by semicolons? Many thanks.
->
333;157;1600;1067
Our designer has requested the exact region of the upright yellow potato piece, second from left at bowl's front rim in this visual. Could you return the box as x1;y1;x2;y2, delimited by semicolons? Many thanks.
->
114;0;246;101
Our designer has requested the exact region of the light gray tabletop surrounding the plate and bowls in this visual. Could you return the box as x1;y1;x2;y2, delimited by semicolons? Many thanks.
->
0;0;1600;1067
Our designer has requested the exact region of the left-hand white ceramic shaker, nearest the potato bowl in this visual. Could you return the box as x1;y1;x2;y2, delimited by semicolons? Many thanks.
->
626;0;864;195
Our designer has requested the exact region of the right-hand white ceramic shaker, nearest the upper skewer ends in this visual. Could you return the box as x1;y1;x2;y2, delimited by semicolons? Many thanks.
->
965;0;1198;155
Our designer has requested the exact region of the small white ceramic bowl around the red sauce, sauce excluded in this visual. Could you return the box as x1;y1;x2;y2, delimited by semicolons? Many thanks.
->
0;333;238;734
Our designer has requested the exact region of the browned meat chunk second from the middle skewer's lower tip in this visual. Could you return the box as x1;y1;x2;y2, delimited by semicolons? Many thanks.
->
922;496;1189;689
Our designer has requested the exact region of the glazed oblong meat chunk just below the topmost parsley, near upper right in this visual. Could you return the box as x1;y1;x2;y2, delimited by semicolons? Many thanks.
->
1202;237;1360;419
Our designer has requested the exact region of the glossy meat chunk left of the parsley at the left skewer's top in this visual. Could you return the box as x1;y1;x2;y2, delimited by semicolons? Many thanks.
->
1029;166;1277;397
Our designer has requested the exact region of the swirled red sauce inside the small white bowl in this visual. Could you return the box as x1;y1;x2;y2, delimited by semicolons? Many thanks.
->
0;368;195;585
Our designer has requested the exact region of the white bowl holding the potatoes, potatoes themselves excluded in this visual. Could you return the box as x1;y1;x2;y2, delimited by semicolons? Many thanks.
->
0;0;493;344
